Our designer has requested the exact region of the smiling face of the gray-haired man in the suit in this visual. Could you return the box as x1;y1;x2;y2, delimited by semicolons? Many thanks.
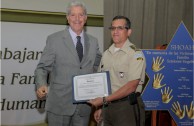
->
67;6;87;35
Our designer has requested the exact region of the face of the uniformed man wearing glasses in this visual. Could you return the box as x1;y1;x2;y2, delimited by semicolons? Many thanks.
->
111;19;131;48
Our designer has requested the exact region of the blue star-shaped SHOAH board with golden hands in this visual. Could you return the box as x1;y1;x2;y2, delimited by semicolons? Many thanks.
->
142;23;194;126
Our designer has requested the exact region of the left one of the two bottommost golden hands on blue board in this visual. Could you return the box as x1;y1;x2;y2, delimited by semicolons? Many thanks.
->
171;101;185;119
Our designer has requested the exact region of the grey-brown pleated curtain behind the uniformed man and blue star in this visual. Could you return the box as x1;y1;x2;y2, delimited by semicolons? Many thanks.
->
104;0;193;49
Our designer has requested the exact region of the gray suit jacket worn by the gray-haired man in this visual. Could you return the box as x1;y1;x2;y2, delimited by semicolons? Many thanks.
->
35;28;101;116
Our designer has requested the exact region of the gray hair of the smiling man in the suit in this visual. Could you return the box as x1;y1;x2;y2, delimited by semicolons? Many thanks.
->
66;1;87;16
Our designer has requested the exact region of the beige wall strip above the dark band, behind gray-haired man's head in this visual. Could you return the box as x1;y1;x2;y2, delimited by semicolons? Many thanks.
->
1;0;104;15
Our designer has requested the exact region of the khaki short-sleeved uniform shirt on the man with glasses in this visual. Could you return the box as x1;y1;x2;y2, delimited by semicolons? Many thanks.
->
99;40;146;93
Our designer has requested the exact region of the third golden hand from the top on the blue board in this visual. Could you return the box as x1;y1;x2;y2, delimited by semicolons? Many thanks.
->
161;87;173;103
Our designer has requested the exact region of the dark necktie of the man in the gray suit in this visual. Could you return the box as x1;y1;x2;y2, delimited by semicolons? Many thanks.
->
76;36;83;62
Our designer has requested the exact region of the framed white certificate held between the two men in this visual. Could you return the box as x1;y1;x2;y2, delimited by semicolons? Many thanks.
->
73;72;111;103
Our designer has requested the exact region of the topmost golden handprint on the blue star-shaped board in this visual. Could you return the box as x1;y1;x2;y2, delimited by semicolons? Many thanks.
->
152;56;165;72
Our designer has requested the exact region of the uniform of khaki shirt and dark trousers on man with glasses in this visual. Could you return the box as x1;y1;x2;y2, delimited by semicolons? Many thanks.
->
99;40;146;126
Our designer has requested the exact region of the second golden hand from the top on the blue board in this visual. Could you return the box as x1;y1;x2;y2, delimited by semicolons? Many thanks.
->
153;74;166;89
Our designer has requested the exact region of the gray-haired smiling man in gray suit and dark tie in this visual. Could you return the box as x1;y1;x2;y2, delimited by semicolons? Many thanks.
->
35;1;101;126
